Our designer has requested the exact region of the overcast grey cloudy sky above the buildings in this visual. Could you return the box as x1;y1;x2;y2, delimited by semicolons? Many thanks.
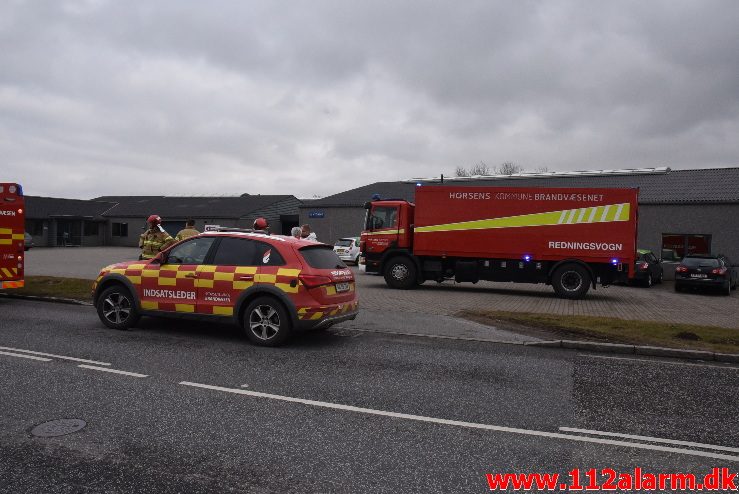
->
0;0;739;198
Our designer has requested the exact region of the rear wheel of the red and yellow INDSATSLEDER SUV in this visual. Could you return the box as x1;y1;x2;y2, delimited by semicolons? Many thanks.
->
243;297;292;346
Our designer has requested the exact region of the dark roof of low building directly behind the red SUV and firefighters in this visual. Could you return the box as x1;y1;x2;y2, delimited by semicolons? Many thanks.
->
96;195;296;219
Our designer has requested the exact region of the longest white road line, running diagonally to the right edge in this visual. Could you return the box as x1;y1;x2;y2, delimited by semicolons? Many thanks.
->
179;381;739;462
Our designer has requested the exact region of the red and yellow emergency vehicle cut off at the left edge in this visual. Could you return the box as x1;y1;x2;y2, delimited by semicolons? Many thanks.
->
0;183;26;289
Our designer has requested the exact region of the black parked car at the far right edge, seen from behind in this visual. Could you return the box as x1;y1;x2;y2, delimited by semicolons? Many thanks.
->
675;255;739;295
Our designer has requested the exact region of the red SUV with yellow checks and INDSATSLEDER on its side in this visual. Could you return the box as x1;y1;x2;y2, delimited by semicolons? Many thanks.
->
93;229;358;346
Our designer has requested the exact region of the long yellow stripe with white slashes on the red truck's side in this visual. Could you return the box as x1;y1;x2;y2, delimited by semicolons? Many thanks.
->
414;202;631;233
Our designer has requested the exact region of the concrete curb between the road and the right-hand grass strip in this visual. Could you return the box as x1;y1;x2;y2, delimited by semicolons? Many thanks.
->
524;340;739;363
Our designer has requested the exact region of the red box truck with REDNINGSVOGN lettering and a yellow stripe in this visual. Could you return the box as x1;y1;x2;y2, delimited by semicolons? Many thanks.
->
360;185;638;299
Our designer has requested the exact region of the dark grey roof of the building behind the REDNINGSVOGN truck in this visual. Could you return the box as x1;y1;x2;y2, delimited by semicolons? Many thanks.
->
310;168;739;207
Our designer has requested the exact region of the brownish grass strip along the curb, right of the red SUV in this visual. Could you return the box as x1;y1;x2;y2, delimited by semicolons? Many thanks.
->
457;310;739;353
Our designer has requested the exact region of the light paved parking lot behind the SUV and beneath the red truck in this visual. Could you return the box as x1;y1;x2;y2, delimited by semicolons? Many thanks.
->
26;247;739;328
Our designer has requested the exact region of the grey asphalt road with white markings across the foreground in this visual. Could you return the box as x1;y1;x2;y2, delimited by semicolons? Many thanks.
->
0;299;739;493
